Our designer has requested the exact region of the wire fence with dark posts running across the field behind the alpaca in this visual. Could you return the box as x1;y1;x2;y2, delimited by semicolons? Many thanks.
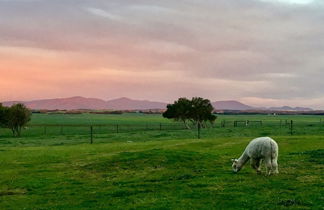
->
0;119;324;143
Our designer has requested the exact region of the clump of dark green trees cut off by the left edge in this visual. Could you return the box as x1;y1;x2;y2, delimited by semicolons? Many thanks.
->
0;104;32;136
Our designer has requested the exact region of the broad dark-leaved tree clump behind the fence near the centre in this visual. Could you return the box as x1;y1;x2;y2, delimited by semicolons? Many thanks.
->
163;97;217;129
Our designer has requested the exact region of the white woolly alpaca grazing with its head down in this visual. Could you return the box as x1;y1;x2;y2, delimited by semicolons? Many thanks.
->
232;137;279;175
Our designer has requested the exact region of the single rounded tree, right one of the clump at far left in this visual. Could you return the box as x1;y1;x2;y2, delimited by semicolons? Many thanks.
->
6;104;31;136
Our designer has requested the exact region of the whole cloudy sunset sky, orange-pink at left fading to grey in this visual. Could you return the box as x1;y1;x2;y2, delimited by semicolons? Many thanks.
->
0;0;324;109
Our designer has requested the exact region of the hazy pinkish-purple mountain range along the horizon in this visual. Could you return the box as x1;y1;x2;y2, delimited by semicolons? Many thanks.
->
2;96;312;111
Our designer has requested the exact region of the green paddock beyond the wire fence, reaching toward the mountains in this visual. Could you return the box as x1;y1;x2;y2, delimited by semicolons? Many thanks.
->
0;114;324;146
